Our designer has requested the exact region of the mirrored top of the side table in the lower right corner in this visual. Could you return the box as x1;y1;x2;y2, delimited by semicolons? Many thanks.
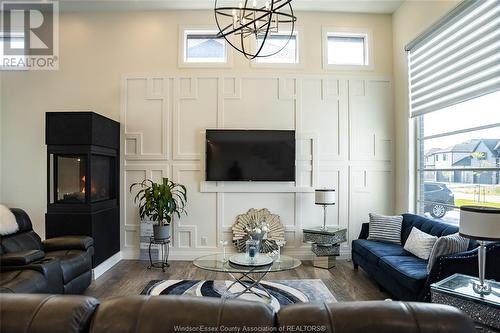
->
431;274;500;307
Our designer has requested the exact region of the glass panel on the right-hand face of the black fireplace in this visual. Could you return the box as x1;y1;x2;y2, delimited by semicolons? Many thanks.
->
90;155;115;202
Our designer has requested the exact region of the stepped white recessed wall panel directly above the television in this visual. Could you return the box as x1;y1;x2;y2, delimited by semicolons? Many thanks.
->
223;78;295;129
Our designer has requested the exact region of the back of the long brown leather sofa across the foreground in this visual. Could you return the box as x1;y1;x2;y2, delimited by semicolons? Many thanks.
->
0;294;475;333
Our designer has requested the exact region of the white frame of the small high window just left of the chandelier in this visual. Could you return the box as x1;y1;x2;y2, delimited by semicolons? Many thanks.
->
178;25;233;68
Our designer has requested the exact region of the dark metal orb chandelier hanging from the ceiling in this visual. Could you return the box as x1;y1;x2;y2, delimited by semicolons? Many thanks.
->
215;0;297;59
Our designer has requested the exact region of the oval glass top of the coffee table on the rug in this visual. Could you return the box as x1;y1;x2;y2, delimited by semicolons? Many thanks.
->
193;253;301;273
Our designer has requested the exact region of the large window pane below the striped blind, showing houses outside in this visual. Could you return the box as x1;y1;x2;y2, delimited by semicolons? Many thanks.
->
417;91;500;223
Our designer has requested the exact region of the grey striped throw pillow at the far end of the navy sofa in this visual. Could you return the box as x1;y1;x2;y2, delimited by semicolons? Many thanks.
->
368;213;403;245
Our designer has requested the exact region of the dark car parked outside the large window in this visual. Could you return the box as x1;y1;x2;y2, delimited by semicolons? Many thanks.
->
424;182;455;218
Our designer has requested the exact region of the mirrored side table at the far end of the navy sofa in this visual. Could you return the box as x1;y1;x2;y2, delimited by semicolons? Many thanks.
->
302;227;347;269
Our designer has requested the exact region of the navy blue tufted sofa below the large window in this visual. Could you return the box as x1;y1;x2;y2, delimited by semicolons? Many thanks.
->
352;214;500;302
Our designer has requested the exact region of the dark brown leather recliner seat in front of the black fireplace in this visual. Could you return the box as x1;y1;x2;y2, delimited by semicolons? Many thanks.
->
0;208;94;294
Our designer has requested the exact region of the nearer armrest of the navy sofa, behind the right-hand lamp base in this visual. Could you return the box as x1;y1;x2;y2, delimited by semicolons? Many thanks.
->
421;243;500;301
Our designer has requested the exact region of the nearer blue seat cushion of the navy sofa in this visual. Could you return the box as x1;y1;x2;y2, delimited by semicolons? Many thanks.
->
379;255;427;293
